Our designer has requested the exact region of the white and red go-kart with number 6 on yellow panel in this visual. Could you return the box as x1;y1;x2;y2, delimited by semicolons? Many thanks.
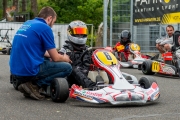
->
69;47;160;105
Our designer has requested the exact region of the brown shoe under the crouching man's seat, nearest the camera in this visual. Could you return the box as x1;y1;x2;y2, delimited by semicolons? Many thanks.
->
21;82;45;100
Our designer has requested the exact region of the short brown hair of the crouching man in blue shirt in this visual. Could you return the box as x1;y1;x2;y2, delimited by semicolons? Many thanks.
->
38;6;57;19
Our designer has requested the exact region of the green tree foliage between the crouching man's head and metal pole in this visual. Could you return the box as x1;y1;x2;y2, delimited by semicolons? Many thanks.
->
39;0;103;28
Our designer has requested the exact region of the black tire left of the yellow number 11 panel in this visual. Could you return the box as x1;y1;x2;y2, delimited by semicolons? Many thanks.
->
141;60;155;75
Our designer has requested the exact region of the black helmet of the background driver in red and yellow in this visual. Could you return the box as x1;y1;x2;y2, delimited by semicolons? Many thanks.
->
119;30;131;43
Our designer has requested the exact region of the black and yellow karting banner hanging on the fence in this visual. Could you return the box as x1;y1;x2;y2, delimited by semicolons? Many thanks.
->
133;0;180;25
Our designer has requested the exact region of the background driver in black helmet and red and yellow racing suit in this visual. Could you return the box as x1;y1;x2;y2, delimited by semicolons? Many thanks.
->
113;30;132;62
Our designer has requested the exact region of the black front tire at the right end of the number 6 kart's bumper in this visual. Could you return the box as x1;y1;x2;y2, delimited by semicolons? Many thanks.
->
138;77;157;89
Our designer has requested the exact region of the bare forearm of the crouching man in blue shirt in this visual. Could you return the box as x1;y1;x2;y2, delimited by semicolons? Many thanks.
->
45;48;72;63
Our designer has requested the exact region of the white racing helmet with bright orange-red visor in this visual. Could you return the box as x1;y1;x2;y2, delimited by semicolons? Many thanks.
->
67;20;87;45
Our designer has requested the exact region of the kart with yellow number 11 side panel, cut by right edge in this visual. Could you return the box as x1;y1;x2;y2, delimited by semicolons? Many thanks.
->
138;31;180;76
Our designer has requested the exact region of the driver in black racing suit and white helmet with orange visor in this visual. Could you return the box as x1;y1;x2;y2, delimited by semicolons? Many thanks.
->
59;20;96;88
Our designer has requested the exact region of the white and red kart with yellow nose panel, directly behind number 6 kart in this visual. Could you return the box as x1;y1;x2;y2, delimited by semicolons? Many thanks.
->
115;43;152;68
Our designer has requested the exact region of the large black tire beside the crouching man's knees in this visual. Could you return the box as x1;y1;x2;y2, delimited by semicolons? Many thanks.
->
50;78;69;102
